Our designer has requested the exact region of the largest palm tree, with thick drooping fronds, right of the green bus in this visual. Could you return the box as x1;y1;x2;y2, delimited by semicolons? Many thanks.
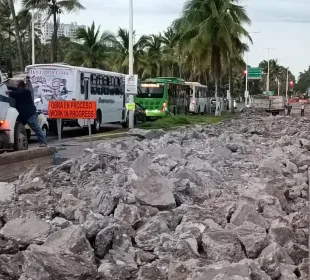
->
174;0;250;100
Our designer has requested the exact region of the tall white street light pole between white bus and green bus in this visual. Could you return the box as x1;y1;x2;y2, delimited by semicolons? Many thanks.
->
128;0;134;128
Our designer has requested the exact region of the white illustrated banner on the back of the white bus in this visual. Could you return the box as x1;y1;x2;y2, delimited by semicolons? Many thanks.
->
27;68;74;114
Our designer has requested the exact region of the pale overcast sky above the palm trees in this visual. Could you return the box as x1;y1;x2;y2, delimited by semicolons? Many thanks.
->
17;0;310;75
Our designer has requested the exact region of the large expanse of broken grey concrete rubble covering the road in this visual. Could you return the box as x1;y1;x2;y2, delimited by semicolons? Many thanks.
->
0;112;310;280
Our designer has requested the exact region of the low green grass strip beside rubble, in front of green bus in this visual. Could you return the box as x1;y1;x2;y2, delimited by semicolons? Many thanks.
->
138;113;231;129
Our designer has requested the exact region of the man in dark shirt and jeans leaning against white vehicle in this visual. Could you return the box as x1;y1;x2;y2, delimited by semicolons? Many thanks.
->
7;81;47;147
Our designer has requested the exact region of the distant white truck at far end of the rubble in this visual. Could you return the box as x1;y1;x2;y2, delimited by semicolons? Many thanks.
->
251;94;285;116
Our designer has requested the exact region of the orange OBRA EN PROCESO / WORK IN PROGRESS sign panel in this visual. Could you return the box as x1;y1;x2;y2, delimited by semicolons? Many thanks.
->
48;101;96;119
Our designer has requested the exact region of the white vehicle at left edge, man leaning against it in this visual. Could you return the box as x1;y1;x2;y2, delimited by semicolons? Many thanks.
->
0;77;28;152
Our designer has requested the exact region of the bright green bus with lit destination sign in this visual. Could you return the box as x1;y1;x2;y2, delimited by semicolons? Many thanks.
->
135;77;191;118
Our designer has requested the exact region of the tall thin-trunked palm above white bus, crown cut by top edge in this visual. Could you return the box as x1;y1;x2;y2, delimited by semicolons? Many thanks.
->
22;0;85;62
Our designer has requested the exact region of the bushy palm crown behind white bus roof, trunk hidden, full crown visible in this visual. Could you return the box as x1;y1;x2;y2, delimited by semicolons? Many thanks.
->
65;22;114;68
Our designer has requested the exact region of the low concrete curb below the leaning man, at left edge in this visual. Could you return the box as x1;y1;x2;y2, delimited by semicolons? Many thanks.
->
0;147;56;166
